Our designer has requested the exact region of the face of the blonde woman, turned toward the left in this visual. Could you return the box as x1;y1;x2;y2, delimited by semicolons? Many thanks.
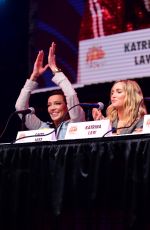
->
110;82;126;109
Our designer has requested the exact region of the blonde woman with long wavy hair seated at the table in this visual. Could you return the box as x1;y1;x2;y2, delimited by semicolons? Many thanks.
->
92;80;147;134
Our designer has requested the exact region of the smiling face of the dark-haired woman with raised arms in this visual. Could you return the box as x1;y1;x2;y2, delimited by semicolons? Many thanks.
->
48;95;67;126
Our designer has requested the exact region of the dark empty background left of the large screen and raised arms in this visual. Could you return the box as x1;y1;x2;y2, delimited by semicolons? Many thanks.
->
0;0;29;142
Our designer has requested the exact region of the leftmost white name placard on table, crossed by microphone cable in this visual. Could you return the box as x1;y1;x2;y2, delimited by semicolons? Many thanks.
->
15;128;56;143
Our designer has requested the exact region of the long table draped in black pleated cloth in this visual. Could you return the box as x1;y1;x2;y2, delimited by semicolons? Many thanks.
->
0;134;150;230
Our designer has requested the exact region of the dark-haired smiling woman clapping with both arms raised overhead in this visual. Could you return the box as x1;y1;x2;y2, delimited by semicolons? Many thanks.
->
15;42;85;139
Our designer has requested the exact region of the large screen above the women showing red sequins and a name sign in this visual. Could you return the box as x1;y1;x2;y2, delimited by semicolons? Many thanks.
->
29;0;150;89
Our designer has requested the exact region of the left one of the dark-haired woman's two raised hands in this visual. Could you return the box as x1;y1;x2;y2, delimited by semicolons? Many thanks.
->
30;50;48;81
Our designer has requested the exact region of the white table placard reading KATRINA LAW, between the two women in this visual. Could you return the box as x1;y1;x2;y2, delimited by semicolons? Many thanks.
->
65;119;112;139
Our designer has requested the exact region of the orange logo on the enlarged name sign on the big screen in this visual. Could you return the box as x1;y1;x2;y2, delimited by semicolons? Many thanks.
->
86;46;105;67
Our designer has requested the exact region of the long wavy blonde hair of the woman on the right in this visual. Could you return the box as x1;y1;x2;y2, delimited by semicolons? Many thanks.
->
106;80;147;125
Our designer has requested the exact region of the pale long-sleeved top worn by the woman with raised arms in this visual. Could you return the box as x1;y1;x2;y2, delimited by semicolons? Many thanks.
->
15;72;85;139
